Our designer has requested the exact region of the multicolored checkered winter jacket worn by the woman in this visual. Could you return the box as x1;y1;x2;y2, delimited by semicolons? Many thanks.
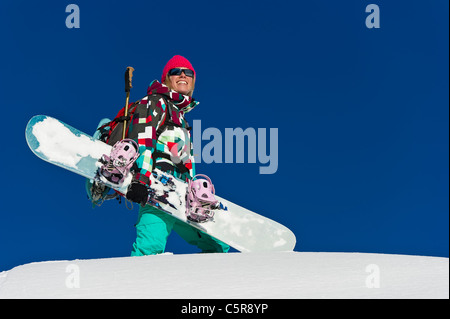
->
127;80;199;185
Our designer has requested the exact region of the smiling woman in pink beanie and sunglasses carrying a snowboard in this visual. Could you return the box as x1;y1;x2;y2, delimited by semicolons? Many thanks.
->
119;55;230;256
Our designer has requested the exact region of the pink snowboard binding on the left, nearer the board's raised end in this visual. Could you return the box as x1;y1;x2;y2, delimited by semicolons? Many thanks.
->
97;139;139;186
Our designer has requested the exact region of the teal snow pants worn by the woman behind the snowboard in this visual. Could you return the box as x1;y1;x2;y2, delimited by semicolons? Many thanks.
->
131;205;230;256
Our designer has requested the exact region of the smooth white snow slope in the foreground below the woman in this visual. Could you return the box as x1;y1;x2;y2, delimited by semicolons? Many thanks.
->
0;252;449;299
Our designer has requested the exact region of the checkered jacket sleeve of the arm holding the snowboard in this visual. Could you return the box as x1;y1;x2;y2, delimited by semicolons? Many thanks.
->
129;96;166;185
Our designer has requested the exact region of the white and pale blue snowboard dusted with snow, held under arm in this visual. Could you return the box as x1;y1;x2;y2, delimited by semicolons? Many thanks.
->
25;115;296;252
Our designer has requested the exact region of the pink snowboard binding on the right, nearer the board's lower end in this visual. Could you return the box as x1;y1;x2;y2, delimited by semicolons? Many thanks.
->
186;174;221;223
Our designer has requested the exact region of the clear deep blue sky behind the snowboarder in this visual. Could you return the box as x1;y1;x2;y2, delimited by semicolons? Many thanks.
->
0;0;449;271
